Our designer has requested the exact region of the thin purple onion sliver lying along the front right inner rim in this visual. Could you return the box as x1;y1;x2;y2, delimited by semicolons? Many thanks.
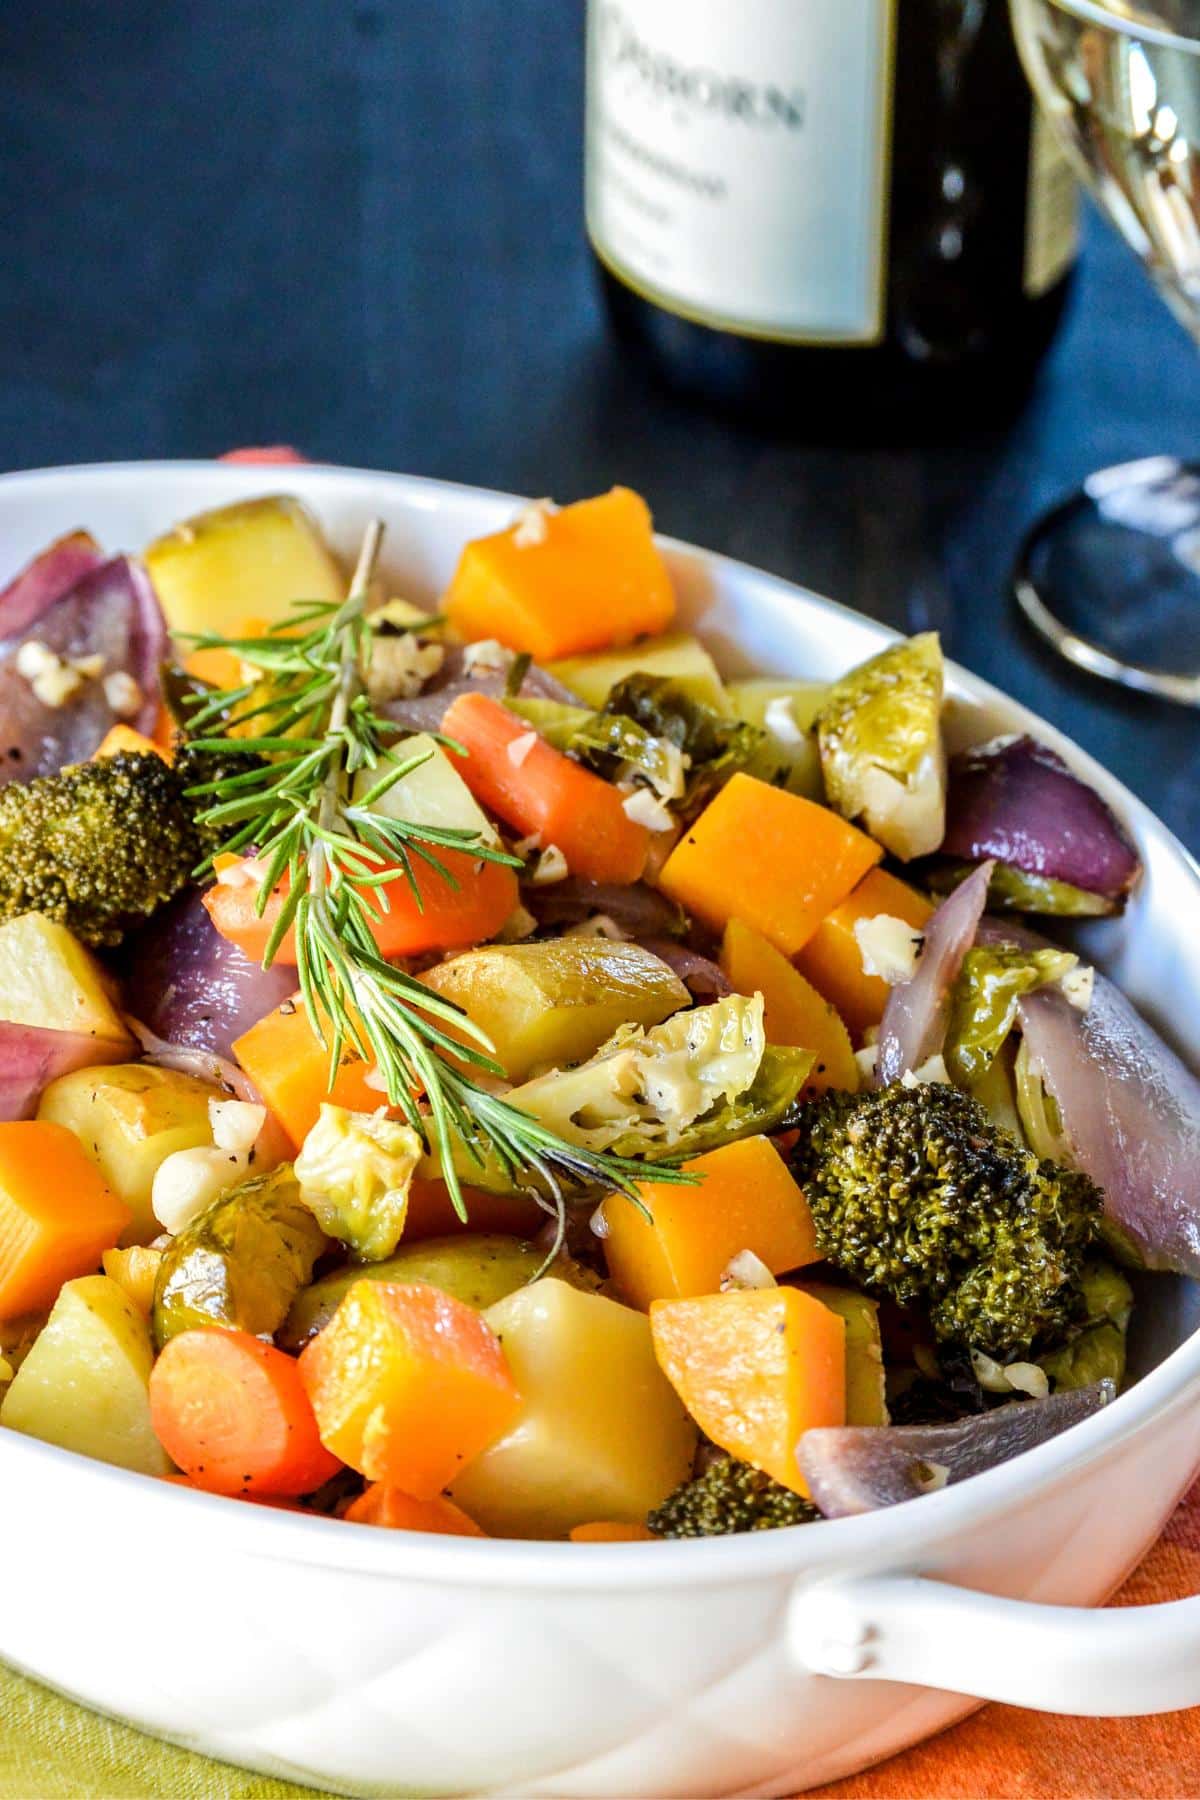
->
795;1381;1117;1519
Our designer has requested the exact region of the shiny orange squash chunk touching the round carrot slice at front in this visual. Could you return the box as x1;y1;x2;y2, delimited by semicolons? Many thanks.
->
300;1280;520;1499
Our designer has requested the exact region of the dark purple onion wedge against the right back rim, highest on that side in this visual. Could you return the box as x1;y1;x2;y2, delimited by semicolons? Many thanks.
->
941;736;1141;902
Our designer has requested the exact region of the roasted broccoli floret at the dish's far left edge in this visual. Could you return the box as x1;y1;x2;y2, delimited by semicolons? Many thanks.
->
0;751;207;945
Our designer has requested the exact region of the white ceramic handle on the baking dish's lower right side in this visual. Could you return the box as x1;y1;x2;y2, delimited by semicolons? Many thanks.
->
788;1575;1200;1717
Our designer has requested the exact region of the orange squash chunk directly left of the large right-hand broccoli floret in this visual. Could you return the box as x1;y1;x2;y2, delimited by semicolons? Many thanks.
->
604;1138;820;1310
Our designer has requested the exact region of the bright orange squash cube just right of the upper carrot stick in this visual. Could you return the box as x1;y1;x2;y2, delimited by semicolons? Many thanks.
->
658;774;883;956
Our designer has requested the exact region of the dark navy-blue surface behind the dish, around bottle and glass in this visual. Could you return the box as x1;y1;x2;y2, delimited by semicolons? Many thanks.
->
0;0;1200;850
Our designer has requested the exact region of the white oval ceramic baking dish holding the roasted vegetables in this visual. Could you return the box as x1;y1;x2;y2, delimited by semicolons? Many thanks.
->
0;463;1200;1796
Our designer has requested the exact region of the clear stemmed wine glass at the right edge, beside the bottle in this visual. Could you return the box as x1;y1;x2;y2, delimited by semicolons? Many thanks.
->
1011;0;1200;706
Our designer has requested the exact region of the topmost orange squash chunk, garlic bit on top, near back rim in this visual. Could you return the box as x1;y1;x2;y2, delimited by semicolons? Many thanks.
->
443;488;675;662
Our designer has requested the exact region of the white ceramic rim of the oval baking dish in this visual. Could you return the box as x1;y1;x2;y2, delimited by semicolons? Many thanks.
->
0;459;1200;1591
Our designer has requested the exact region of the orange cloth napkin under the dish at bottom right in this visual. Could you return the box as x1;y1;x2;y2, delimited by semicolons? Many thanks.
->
804;1481;1200;1800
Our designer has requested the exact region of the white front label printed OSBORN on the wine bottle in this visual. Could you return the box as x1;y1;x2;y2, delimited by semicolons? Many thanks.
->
587;0;896;344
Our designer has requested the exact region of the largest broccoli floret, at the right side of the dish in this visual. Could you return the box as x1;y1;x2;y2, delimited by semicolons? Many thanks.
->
792;1082;1103;1361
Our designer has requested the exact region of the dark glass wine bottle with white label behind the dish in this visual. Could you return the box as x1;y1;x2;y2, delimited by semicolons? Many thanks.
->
585;0;1076;432
